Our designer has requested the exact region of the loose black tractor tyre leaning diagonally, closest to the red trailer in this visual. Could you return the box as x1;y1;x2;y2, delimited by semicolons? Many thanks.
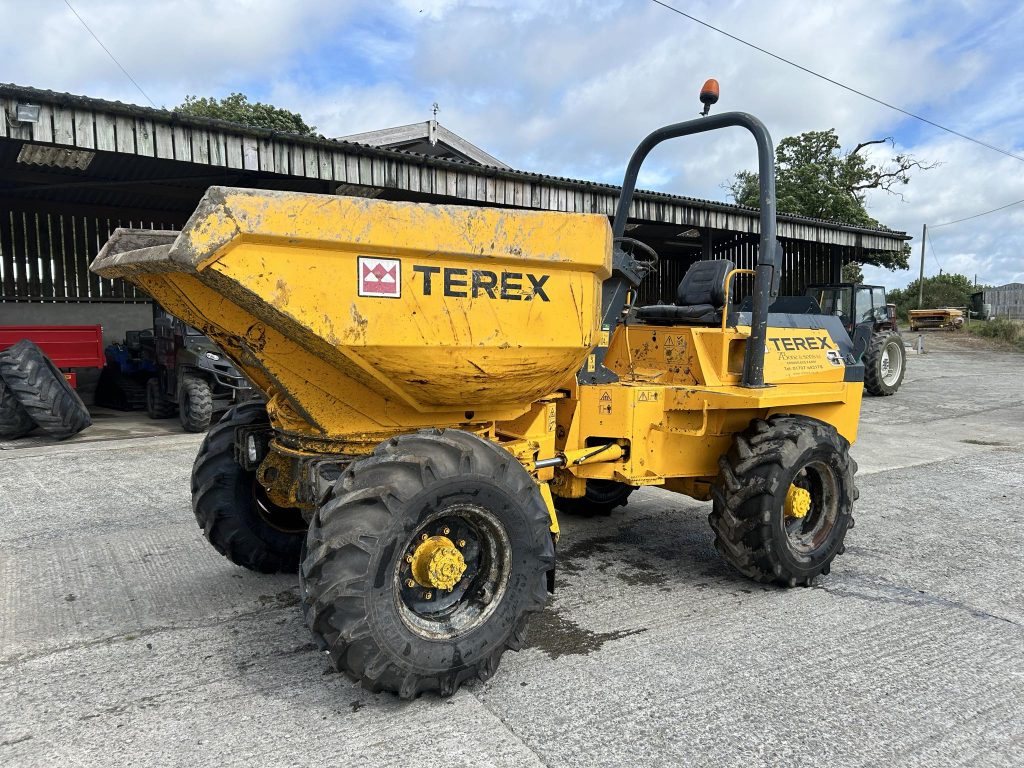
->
0;339;92;440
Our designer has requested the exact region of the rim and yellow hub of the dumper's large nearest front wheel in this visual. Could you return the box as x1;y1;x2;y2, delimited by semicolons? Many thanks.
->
394;504;512;640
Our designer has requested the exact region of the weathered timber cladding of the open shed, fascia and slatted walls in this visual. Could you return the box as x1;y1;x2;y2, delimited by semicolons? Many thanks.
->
0;84;908;303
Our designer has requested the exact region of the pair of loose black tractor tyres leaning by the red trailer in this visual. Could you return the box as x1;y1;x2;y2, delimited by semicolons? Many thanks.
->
0;339;92;440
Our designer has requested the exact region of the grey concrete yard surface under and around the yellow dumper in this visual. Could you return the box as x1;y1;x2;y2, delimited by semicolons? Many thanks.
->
0;334;1024;768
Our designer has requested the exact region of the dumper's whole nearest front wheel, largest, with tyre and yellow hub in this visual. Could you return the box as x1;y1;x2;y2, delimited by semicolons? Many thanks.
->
299;429;555;698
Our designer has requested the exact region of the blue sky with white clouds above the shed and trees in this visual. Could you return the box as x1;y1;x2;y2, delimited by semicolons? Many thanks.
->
0;0;1024;288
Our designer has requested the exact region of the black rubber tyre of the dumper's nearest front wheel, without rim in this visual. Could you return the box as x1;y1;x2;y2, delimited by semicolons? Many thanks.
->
299;429;554;699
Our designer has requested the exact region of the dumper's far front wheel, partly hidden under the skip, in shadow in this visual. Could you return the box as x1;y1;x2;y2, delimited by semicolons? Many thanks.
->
191;402;306;573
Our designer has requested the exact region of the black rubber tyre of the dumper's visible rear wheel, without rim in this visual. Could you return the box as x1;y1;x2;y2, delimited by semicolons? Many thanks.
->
708;415;859;587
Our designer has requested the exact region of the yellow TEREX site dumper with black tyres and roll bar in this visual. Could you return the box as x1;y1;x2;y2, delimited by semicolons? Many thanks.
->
92;99;863;697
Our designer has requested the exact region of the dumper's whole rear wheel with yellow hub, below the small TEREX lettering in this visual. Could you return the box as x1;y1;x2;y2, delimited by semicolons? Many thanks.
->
708;416;858;587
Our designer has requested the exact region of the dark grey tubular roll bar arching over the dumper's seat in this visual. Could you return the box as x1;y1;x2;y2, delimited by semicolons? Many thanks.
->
611;112;782;388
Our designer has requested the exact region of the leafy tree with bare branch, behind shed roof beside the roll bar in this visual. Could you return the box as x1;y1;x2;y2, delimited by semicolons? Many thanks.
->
726;128;938;269
